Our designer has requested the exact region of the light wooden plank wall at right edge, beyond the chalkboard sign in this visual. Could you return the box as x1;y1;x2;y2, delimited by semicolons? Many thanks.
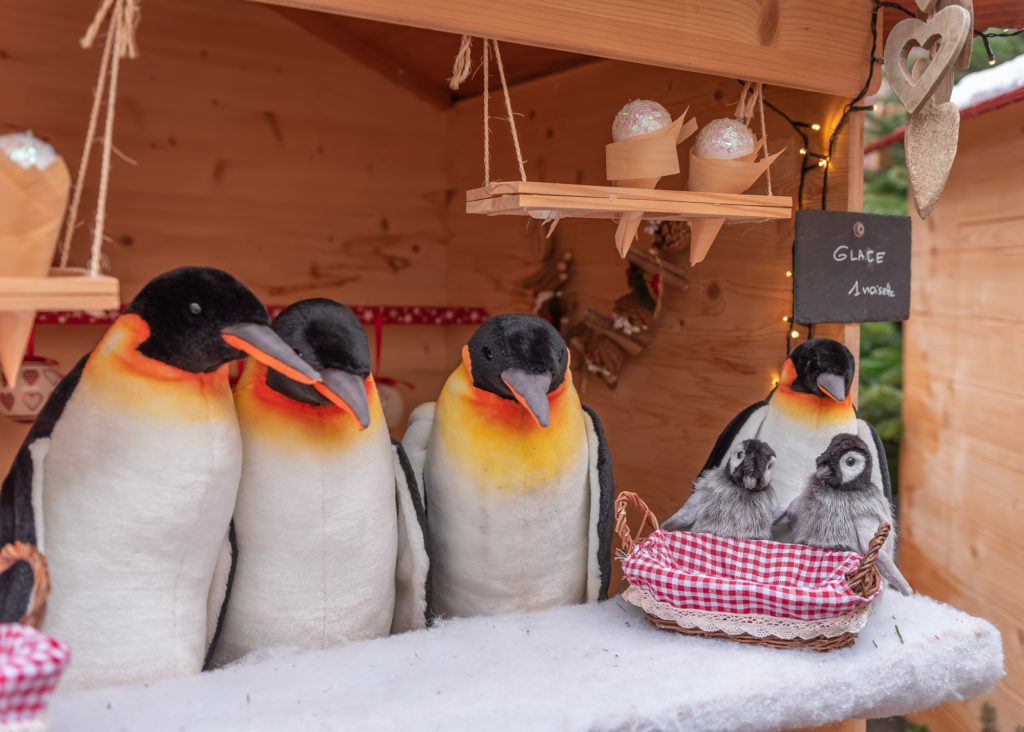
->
900;104;1024;730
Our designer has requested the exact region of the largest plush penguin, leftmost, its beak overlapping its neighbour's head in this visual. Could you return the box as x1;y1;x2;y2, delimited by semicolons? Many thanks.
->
0;267;317;687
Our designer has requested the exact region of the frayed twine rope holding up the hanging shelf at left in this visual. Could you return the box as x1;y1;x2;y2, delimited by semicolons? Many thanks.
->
60;0;139;276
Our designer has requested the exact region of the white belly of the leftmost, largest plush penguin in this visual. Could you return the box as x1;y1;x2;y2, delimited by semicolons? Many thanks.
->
42;374;242;686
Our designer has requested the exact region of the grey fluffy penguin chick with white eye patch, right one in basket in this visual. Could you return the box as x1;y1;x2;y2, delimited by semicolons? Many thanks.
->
784;434;913;595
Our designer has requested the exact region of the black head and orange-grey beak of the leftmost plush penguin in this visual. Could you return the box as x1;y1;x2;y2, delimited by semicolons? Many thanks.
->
125;267;318;383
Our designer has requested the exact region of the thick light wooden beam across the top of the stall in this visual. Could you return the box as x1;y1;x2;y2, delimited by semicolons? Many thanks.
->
245;0;871;96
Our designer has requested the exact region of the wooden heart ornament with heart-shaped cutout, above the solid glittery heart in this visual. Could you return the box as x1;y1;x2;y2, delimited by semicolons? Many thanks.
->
884;5;971;114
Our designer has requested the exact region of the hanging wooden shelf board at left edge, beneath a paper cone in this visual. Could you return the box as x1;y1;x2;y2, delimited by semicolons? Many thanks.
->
0;267;121;311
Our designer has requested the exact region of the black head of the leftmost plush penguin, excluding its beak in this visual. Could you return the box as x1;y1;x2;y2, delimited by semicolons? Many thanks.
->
125;267;270;374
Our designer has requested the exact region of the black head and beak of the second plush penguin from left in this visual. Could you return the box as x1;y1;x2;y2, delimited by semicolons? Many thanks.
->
266;298;370;429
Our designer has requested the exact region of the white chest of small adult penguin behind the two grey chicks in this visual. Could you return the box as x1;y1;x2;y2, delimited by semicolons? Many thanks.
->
756;404;857;508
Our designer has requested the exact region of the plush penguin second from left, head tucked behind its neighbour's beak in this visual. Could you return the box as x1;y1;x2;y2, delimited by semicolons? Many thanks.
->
213;299;429;665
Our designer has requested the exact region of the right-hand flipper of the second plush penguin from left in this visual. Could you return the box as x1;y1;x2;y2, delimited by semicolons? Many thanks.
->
391;437;434;634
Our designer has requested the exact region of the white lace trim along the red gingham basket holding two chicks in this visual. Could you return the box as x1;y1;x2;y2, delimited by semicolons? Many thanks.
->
623;585;870;640
